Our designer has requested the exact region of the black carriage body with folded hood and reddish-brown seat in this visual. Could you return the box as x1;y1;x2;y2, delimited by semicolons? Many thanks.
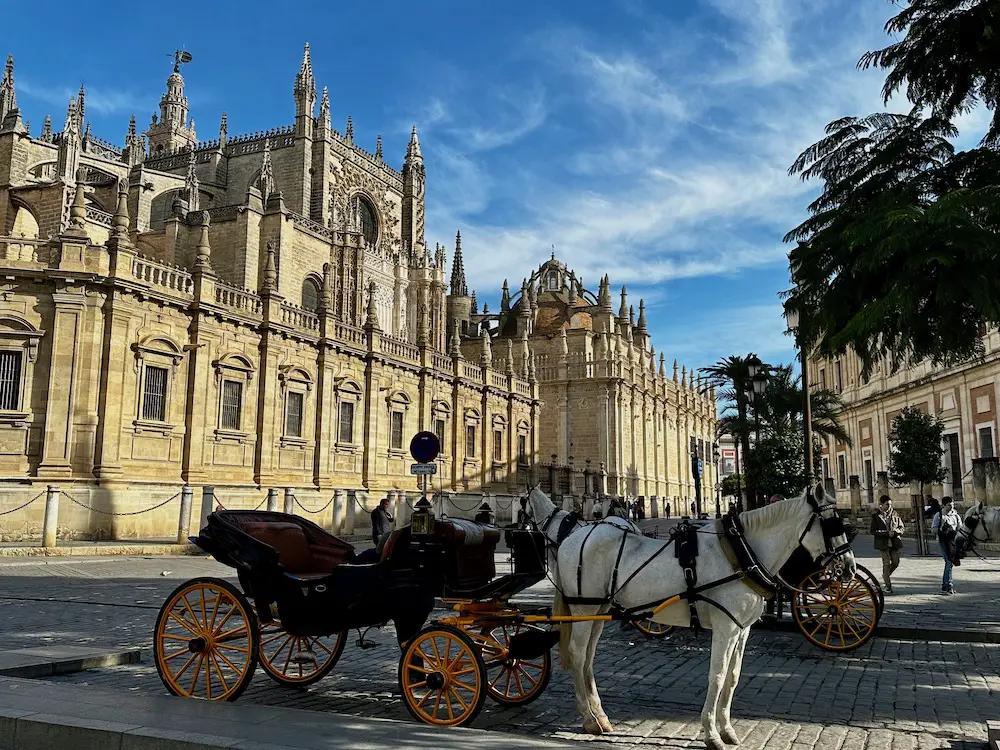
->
195;511;434;641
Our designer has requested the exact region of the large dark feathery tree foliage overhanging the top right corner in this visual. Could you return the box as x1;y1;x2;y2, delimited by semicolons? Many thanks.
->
785;0;1000;378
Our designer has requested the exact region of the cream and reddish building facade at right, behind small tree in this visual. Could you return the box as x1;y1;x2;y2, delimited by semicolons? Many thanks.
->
809;329;1000;507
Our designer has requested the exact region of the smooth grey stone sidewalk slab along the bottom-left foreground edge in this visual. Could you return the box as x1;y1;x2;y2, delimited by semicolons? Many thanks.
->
0;678;572;750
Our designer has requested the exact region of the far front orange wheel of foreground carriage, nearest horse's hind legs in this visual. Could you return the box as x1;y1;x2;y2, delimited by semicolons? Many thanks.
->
469;623;552;706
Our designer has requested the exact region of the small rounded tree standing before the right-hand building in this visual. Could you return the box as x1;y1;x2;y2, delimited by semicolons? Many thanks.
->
889;406;948;505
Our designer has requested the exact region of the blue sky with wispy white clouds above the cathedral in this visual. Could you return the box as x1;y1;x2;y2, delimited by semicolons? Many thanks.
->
0;0;983;376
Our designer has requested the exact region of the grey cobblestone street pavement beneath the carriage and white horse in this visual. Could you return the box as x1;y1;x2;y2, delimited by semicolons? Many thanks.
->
0;558;1000;750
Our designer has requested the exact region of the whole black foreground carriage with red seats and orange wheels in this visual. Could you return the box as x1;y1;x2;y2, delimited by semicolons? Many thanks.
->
154;511;555;726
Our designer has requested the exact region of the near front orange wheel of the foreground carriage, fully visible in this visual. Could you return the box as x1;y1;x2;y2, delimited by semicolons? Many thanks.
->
399;625;487;727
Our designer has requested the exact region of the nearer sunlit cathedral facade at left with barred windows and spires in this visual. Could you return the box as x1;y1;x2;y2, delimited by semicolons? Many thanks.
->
0;50;540;538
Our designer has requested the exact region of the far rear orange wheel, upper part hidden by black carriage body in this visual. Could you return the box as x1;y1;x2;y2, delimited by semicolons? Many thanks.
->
258;620;347;687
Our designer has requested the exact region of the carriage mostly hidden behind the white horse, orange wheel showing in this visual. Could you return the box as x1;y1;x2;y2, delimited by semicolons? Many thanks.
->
635;524;885;652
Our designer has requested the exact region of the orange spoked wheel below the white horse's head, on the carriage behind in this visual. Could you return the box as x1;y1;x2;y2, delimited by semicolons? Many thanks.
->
792;571;880;651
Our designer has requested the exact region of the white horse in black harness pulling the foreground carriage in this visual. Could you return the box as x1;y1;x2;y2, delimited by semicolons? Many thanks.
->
529;486;856;750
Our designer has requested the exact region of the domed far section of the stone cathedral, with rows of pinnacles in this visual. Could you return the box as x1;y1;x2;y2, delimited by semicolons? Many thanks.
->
450;255;717;515
